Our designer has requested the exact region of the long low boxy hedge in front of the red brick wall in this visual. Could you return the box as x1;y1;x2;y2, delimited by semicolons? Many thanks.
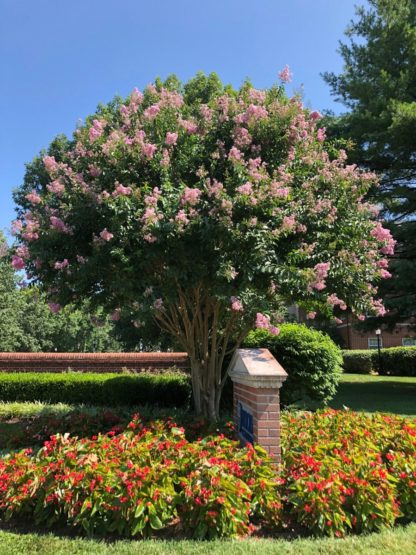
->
0;372;191;407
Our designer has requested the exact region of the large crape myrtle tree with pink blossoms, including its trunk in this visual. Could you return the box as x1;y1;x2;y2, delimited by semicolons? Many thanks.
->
13;73;393;420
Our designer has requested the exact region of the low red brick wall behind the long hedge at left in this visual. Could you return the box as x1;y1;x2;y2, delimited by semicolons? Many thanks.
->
0;353;189;372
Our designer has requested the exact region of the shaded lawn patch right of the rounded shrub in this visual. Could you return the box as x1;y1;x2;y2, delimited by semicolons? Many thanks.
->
330;374;416;414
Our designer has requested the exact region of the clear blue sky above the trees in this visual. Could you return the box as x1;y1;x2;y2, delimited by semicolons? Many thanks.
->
0;0;364;239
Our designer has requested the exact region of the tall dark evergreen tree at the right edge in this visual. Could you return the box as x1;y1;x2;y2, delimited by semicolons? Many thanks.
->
324;0;416;322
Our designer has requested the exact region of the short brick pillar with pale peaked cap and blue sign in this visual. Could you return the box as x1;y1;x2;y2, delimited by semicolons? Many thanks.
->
229;349;287;462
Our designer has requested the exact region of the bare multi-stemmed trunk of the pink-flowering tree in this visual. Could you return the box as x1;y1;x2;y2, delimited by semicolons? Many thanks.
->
156;286;248;421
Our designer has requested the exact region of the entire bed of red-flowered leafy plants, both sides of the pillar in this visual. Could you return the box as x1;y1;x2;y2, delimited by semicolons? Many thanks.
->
0;410;416;538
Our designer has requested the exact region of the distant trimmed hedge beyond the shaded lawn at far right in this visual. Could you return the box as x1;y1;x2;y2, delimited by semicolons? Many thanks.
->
342;347;416;377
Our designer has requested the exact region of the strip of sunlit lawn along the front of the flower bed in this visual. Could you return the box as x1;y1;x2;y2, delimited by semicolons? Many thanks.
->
0;524;416;555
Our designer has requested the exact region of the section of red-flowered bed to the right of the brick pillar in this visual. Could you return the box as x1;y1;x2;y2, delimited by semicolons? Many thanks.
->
283;410;416;536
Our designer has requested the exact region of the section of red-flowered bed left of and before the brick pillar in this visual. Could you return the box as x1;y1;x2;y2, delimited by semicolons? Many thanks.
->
0;419;281;538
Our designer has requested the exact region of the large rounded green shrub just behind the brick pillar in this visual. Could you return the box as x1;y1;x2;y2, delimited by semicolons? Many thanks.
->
244;324;342;406
